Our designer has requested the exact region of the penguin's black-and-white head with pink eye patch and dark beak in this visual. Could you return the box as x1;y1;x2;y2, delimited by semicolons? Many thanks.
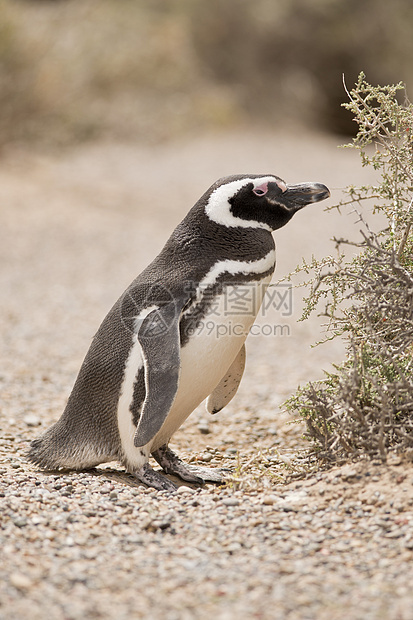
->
205;175;330;231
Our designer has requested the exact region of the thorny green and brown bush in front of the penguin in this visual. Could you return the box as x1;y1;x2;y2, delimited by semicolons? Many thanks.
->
286;74;413;461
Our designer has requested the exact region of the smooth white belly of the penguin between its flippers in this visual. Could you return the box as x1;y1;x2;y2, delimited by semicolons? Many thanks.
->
150;275;271;451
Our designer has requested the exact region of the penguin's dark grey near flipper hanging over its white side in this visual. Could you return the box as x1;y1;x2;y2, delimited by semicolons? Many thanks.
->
134;303;181;448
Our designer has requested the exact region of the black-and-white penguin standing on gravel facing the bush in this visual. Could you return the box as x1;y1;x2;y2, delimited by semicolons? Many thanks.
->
29;175;329;491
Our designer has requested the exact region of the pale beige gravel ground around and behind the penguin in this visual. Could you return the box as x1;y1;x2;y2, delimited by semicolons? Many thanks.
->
0;130;413;620
